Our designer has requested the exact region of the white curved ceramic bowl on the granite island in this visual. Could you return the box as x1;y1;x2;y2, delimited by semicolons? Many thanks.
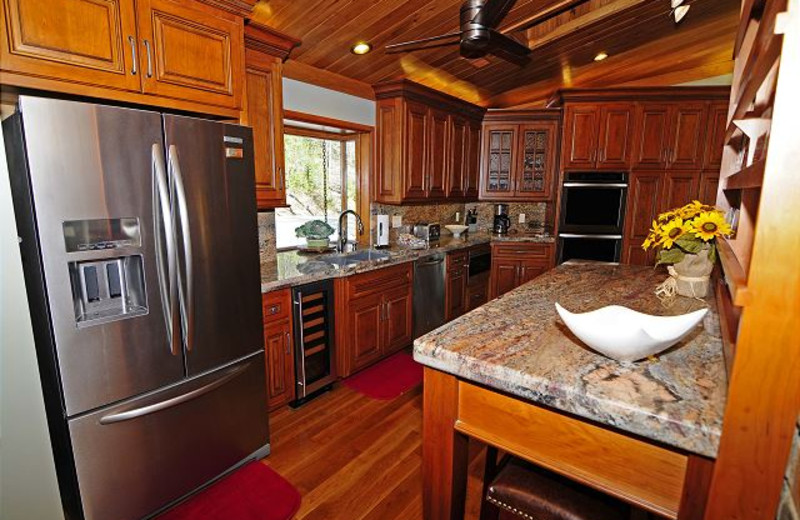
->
556;303;708;361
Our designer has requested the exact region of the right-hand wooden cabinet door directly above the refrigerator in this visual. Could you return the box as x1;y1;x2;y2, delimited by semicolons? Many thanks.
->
137;0;244;108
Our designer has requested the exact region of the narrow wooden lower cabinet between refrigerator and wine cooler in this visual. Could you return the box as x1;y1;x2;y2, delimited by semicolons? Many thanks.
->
262;289;295;410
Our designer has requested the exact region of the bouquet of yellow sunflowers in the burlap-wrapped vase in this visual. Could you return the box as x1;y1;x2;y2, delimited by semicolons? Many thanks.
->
642;200;731;265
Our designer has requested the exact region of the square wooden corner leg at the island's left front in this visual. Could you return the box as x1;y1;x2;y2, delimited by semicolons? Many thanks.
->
422;367;468;520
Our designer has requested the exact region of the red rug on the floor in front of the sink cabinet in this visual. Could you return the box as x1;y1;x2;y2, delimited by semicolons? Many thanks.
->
344;352;422;401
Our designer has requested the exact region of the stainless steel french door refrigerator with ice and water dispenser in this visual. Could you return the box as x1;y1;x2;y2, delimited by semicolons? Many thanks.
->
3;97;269;520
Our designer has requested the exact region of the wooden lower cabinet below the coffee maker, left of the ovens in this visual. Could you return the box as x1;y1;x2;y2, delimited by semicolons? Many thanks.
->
489;242;555;298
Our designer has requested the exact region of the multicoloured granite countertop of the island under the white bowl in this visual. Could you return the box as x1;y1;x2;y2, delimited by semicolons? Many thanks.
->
414;264;727;457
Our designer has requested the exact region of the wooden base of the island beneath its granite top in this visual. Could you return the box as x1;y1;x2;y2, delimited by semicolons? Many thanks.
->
422;367;713;520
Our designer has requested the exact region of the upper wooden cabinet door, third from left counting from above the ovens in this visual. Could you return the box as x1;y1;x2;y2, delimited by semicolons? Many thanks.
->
632;103;671;170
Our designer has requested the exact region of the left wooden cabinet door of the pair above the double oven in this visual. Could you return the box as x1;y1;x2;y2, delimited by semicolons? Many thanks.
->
562;104;600;170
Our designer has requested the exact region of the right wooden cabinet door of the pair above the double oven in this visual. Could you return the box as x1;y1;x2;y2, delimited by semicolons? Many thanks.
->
596;103;634;170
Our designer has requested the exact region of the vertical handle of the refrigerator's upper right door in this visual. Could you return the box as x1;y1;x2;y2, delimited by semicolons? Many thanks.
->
168;144;194;352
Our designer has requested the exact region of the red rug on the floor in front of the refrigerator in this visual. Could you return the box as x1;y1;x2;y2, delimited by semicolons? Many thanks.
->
158;462;300;520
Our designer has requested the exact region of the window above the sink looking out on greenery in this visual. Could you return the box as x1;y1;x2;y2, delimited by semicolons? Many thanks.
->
275;132;358;249
